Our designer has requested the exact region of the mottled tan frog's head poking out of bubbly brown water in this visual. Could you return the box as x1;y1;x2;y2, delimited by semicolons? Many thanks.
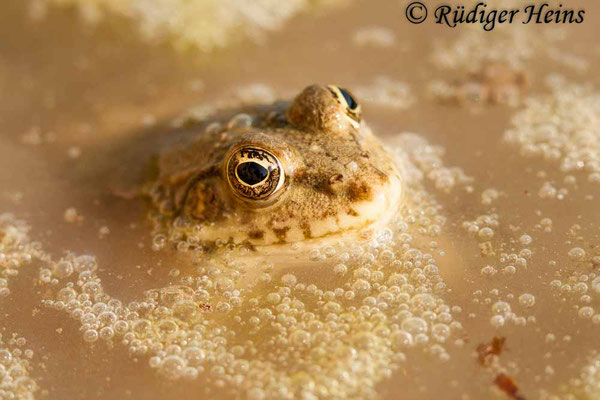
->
142;84;402;248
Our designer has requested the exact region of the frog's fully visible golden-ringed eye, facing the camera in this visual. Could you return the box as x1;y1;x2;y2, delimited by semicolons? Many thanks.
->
227;145;285;200
